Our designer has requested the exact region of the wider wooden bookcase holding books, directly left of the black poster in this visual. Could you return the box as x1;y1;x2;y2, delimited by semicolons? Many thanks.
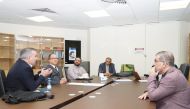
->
15;35;64;72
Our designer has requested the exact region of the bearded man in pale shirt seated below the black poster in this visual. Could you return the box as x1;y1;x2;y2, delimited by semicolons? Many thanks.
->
67;58;89;80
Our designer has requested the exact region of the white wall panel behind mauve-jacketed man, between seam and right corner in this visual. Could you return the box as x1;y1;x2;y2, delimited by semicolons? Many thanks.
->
146;22;180;72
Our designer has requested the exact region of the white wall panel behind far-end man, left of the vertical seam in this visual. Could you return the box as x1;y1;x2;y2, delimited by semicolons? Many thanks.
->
90;24;145;75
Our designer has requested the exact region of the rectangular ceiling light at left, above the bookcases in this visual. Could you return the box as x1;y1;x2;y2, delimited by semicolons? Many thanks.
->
27;16;53;22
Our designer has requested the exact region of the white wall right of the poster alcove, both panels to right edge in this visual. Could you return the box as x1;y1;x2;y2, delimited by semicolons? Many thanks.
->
90;21;188;75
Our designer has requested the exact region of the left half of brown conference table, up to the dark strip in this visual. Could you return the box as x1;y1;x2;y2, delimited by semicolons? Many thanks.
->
0;78;112;109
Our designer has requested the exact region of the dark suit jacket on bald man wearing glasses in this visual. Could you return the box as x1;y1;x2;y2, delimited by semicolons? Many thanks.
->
47;64;63;85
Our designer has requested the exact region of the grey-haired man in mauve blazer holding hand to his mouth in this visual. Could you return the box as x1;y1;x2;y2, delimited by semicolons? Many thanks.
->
139;51;190;109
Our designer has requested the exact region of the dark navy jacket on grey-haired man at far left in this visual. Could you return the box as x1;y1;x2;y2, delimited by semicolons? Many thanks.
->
5;59;45;91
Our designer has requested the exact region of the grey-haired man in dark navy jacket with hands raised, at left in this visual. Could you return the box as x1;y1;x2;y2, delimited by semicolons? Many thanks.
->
5;48;52;91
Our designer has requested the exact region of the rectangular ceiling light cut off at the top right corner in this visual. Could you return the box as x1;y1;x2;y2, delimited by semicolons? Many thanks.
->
160;0;189;10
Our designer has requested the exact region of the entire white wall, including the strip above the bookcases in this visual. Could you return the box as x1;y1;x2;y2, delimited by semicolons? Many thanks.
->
0;21;190;75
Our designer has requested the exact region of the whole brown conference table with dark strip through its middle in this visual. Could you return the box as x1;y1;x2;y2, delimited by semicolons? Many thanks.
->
0;77;156;109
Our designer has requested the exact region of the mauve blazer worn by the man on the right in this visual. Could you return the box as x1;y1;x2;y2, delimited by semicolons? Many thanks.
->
148;67;190;109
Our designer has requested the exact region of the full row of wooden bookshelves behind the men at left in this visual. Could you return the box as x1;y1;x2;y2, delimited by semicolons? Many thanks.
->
0;33;64;72
